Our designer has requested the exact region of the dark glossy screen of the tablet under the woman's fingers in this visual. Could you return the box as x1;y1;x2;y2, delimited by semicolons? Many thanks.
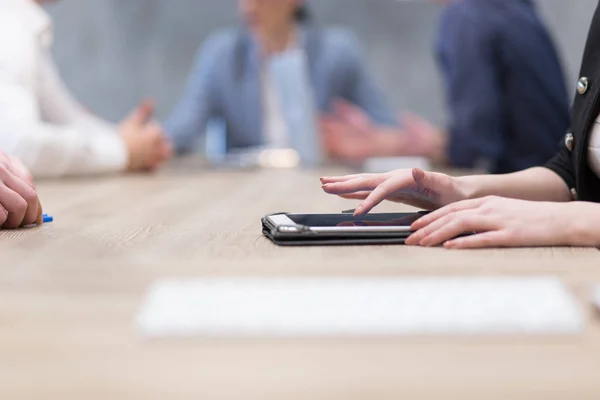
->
287;213;424;227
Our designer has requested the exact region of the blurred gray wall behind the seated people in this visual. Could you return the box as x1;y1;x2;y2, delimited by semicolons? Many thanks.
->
48;0;597;122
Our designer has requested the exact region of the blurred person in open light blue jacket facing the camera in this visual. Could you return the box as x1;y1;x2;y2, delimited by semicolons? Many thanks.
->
165;0;395;162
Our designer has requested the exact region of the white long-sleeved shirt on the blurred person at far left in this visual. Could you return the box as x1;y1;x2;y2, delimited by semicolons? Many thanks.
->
0;0;128;178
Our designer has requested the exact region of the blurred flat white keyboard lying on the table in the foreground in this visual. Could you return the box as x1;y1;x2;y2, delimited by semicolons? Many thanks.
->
137;277;585;337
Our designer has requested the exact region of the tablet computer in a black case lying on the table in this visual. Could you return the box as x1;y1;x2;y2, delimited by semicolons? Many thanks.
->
262;212;427;246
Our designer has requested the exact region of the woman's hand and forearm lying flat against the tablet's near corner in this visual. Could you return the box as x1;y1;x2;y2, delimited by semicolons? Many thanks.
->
406;197;600;249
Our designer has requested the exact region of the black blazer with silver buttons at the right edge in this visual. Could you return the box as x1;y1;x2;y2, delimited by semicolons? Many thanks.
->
546;3;600;203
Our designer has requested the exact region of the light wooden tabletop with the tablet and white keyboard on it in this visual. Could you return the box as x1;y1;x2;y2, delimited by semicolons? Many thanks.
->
0;164;600;400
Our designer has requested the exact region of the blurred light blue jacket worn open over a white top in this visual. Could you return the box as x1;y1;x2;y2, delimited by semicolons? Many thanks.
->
165;24;395;153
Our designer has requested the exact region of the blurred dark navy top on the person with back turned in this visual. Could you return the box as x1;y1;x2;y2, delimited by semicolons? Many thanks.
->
438;0;569;173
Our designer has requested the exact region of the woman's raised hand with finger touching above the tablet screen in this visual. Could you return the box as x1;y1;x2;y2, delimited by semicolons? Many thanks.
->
321;169;469;216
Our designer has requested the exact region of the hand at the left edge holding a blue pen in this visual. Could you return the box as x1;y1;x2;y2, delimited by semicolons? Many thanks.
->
0;152;42;229
